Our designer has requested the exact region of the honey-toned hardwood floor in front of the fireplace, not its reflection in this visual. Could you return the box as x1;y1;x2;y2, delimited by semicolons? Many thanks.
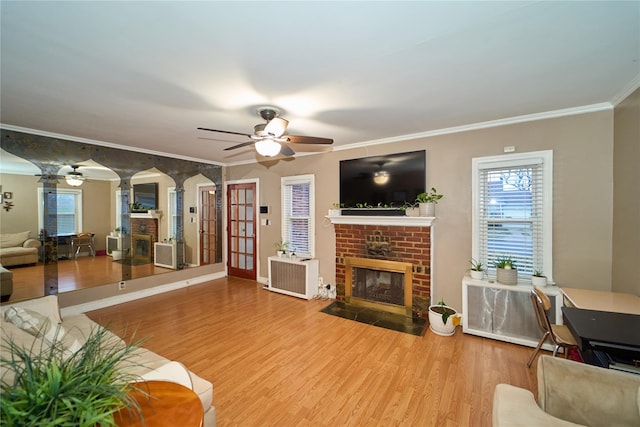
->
87;278;537;427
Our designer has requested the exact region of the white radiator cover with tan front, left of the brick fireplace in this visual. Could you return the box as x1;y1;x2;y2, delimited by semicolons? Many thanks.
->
268;256;319;299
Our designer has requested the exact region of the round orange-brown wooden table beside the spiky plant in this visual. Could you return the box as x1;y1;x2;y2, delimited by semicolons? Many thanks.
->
114;381;204;427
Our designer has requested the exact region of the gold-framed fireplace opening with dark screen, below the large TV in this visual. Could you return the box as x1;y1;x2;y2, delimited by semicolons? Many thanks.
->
345;258;413;316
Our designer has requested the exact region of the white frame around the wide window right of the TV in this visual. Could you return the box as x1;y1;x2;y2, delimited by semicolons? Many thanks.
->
471;150;554;283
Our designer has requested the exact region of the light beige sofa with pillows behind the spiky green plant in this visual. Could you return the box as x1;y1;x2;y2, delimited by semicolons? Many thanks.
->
0;295;216;427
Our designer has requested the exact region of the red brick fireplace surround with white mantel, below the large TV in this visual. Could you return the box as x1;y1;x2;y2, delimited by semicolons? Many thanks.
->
329;216;434;311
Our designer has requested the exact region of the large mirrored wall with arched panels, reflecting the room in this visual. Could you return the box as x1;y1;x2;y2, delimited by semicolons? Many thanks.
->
0;129;221;301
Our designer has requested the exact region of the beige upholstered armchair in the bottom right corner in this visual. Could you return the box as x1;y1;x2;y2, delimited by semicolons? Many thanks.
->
493;355;640;427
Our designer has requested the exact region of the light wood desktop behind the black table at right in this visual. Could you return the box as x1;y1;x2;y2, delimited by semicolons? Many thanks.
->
562;288;640;314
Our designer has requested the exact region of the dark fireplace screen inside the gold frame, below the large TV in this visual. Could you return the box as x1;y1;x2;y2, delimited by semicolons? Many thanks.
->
352;267;404;305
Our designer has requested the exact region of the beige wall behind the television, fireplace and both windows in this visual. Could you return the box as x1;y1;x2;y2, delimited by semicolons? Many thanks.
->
225;110;613;309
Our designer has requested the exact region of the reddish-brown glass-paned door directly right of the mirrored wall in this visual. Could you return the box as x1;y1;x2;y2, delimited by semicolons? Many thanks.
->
227;183;257;280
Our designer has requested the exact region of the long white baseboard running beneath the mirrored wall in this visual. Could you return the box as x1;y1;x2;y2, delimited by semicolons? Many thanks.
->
60;272;226;317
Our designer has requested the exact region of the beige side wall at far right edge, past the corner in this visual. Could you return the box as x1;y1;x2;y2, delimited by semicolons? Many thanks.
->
612;89;640;295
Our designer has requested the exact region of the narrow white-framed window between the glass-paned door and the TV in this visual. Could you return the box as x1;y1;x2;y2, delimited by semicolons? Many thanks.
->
282;175;315;258
